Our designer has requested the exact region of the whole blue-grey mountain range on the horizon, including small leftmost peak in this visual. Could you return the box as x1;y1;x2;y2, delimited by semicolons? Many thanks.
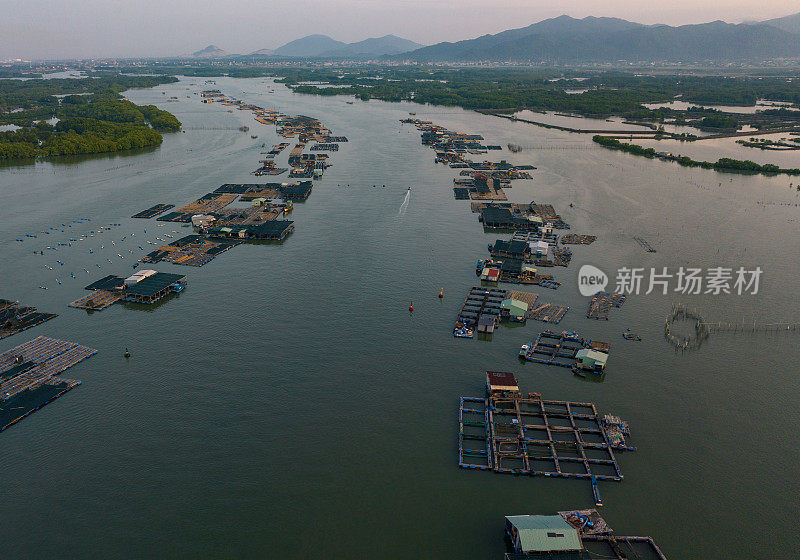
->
191;13;800;64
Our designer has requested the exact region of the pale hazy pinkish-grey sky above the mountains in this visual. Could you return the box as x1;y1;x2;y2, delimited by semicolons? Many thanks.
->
0;0;800;59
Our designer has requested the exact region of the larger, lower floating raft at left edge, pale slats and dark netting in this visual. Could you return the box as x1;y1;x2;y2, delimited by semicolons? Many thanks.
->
0;336;97;431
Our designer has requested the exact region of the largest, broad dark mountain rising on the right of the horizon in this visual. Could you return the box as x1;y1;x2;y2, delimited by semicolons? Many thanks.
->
394;16;800;64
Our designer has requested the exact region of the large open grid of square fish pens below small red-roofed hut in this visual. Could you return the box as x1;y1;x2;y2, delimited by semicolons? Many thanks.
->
458;384;636;481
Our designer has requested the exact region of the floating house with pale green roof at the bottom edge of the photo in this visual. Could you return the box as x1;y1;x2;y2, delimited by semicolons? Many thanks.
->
506;515;588;558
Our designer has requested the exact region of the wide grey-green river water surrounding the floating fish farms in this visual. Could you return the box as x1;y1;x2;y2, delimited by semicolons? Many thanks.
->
0;77;800;560
